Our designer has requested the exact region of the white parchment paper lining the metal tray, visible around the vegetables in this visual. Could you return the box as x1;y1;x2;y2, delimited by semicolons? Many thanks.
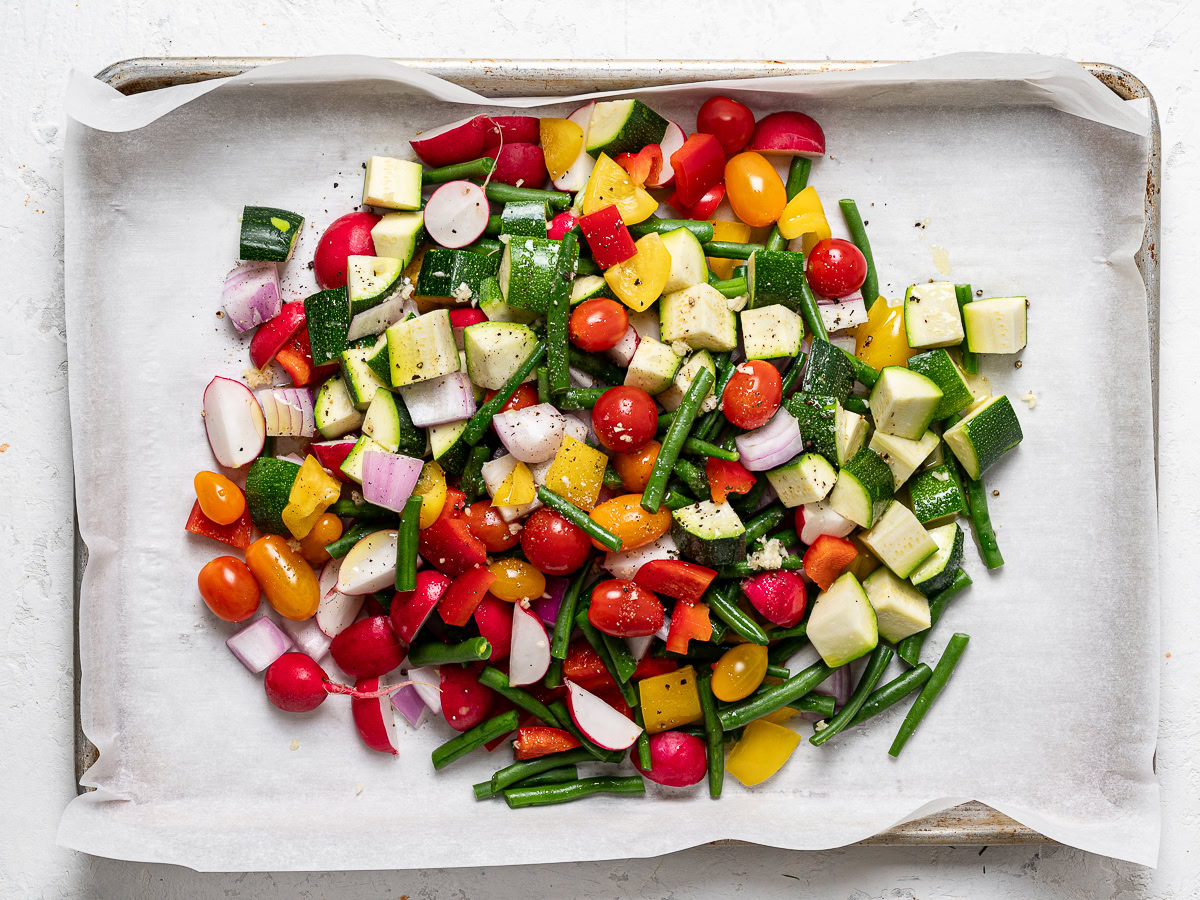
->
61;55;1158;869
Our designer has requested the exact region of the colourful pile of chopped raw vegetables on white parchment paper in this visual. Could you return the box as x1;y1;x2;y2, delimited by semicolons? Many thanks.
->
187;97;1027;808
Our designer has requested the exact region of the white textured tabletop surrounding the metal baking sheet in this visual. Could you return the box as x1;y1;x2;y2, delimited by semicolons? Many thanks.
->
0;0;1200;900
